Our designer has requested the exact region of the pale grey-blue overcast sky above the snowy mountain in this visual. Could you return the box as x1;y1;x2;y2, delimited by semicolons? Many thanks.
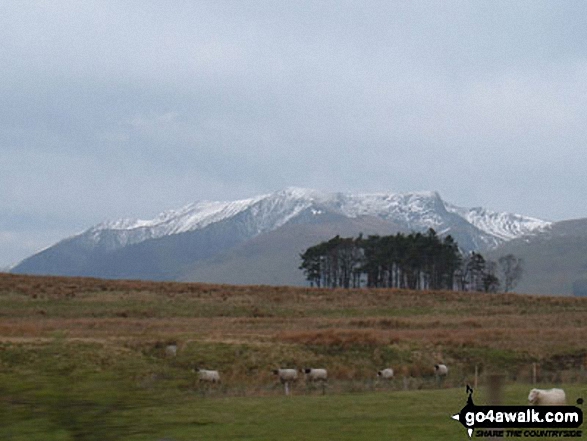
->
0;0;587;268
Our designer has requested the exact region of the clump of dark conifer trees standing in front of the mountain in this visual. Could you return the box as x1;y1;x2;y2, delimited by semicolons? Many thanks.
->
299;229;521;292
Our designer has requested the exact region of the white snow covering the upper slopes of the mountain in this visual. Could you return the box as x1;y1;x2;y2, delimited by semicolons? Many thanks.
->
74;187;550;249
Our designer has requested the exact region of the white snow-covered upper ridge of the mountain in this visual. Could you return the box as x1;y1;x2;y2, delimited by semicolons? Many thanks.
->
72;187;551;246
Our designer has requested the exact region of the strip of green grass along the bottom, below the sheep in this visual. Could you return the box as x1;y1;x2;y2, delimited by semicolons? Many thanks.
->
0;378;587;441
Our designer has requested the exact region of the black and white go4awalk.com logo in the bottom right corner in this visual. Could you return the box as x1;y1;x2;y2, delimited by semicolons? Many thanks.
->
452;386;583;439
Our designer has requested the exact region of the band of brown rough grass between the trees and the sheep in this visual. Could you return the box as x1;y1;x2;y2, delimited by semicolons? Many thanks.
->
0;274;587;386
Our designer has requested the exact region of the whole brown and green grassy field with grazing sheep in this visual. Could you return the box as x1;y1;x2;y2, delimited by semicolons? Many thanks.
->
0;274;587;441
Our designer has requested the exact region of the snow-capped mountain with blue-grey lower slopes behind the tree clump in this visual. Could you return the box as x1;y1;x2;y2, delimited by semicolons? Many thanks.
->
13;188;550;279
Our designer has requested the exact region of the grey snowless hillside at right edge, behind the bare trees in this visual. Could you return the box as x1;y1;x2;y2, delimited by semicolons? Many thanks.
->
488;219;587;295
